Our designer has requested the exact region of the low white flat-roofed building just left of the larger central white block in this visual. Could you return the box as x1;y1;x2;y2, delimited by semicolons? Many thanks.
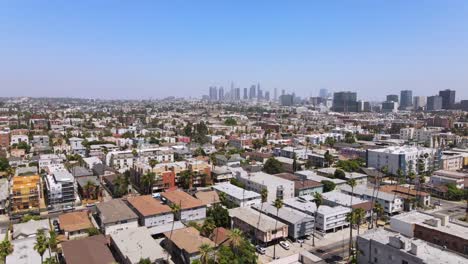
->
211;182;262;207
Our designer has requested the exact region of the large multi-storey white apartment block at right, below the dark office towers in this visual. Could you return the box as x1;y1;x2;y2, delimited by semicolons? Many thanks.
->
367;146;438;175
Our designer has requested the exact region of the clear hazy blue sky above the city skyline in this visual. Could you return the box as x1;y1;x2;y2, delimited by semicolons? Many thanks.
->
0;0;468;99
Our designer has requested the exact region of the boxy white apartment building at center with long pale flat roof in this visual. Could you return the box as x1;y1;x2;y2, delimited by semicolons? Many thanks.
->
234;171;294;202
